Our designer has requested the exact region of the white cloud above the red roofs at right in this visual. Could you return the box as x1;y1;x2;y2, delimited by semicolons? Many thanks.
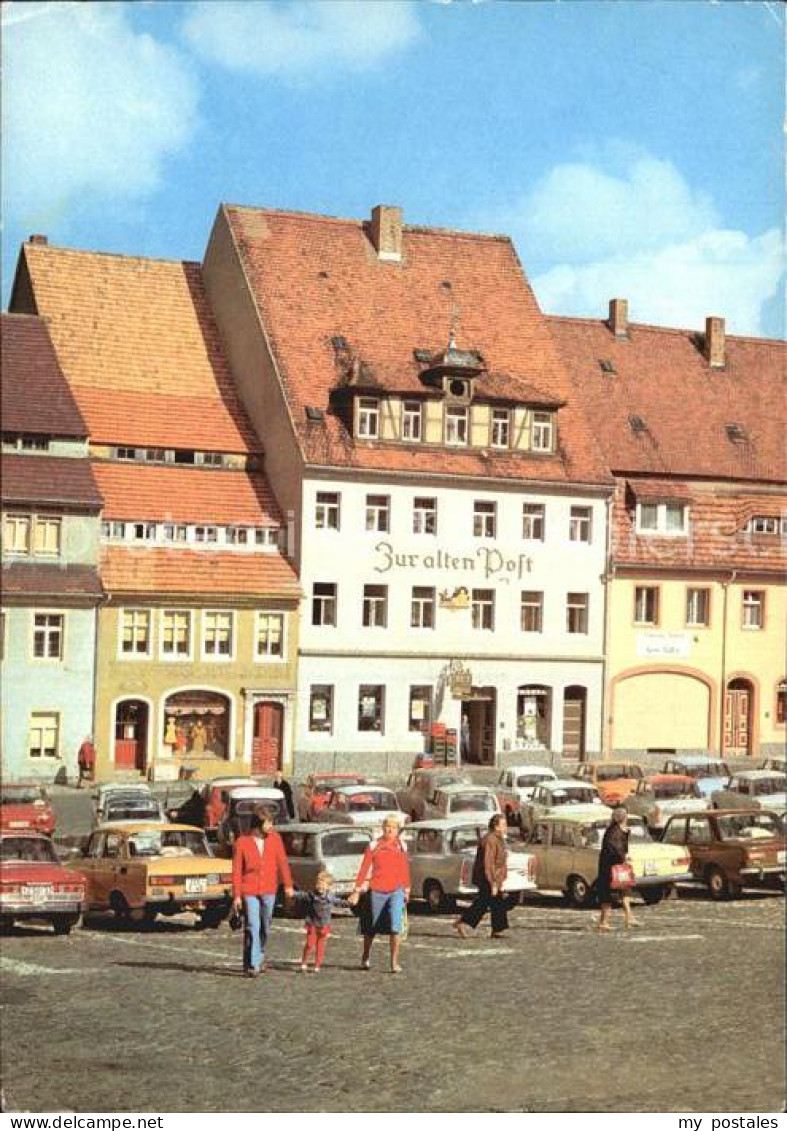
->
496;153;785;335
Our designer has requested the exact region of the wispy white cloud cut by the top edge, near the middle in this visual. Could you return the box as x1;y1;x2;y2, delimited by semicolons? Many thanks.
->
183;0;420;76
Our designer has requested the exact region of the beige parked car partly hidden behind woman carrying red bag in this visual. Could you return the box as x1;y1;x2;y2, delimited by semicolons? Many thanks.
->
526;809;689;907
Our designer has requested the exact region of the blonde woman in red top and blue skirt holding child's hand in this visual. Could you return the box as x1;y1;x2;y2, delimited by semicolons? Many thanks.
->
347;817;409;974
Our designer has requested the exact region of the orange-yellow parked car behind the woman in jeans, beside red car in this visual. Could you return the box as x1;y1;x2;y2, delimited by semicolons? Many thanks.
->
70;821;232;927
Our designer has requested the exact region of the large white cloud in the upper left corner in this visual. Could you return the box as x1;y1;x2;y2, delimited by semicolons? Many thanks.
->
2;2;198;225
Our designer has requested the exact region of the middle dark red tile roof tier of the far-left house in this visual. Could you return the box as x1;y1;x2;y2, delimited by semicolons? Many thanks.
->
0;454;102;511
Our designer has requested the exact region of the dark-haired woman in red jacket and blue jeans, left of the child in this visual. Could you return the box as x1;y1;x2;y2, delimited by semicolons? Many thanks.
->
232;813;293;978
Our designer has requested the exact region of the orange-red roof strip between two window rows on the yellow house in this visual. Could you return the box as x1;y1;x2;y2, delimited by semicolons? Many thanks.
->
93;460;282;526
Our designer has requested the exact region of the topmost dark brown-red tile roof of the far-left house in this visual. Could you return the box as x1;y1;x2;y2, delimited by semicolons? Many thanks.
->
0;314;87;439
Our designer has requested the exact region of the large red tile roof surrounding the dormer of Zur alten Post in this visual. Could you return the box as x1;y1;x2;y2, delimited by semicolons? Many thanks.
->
217;206;609;483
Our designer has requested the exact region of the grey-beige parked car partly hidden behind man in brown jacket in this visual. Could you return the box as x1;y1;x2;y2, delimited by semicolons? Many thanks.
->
403;818;536;913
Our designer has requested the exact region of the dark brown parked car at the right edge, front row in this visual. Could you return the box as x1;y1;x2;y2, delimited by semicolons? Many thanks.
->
664;809;786;899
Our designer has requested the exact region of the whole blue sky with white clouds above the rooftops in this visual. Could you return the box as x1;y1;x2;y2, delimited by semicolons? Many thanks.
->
2;0;786;337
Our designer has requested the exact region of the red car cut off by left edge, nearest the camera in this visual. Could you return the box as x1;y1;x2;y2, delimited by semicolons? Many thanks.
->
0;830;85;934
